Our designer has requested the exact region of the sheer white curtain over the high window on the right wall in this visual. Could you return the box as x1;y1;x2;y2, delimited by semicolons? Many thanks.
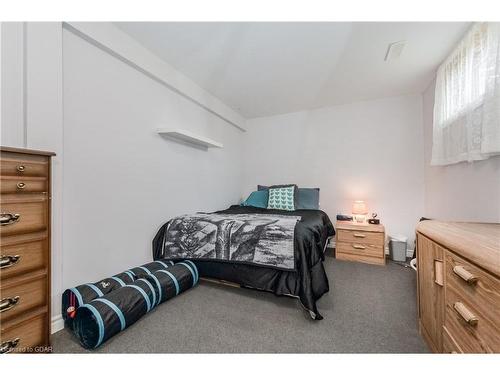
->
431;23;500;165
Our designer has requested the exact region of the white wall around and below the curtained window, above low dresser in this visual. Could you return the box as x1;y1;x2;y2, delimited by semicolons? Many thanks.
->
423;82;500;223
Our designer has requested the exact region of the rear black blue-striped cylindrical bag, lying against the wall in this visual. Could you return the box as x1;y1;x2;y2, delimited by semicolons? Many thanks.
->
61;261;174;329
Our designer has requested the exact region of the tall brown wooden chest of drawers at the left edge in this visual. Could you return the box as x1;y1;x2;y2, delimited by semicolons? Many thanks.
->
0;147;54;353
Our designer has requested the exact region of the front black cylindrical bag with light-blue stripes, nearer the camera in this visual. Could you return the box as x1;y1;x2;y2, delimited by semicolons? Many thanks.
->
73;260;199;349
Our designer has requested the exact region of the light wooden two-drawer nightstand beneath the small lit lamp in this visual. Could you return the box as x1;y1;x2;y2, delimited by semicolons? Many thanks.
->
335;221;385;265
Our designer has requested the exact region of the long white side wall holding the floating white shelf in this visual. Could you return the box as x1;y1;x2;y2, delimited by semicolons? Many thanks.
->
63;30;243;287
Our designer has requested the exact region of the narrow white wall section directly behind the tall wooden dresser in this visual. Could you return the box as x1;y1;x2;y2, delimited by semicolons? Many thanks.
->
1;22;63;332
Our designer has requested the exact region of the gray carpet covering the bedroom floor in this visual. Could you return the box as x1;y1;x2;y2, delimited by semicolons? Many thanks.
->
52;257;428;353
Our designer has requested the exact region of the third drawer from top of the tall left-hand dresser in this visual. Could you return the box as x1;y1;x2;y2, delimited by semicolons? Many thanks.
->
0;198;48;236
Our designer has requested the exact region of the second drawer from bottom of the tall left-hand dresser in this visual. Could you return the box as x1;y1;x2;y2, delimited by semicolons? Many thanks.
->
0;271;48;323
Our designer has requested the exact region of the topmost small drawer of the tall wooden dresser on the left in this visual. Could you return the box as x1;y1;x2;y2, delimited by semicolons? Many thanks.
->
0;152;49;177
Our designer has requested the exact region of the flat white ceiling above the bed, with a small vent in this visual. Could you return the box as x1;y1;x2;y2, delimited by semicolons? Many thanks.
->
116;22;470;118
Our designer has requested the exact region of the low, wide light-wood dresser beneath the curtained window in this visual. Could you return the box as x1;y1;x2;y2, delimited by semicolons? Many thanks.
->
417;220;500;353
